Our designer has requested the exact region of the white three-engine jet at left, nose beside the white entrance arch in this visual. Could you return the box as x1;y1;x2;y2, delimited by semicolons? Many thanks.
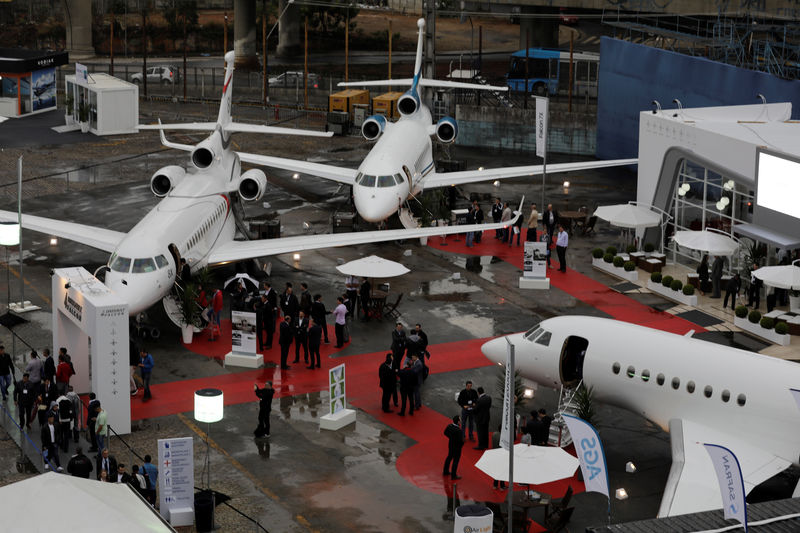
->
0;52;521;314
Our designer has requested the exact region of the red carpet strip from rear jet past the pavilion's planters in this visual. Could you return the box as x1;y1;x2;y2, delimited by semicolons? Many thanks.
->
428;232;705;335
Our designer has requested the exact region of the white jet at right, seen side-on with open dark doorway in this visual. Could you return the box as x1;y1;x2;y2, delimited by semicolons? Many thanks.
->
481;316;800;516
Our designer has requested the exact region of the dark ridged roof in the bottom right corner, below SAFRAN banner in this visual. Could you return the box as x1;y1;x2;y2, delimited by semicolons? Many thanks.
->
586;498;800;533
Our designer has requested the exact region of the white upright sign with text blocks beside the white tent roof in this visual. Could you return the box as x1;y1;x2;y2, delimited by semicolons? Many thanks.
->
158;437;194;526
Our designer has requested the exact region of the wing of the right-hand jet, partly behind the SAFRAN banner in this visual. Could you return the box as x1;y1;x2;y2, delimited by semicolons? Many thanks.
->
658;419;791;517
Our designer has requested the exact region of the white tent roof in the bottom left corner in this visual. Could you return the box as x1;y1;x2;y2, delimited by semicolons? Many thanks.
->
0;472;175;533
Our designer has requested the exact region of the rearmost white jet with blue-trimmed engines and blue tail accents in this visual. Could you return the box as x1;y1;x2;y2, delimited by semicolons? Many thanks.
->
208;19;637;228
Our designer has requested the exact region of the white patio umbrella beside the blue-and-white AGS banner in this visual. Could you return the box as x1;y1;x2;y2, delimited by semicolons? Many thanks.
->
475;444;580;485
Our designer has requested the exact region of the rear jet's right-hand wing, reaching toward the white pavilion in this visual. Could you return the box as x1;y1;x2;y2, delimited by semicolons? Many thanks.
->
424;159;639;189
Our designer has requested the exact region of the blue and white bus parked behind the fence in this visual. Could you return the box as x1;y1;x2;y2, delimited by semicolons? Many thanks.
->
506;48;600;98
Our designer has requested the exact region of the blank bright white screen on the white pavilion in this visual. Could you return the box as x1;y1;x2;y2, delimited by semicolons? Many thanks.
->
756;151;800;219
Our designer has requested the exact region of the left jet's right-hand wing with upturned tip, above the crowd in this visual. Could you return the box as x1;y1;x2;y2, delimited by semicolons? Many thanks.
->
208;203;524;265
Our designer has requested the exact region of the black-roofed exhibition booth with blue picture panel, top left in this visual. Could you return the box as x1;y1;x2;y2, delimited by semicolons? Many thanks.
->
0;48;69;118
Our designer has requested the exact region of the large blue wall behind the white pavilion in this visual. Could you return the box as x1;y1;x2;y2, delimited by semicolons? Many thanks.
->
597;37;800;159
